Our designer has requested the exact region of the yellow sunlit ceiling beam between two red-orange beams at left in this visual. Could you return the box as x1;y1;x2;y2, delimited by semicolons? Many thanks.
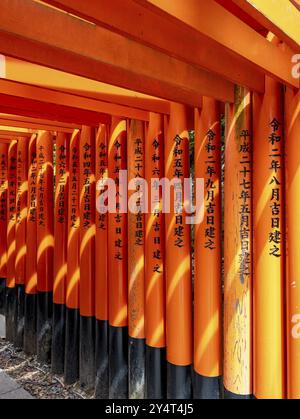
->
0;55;170;114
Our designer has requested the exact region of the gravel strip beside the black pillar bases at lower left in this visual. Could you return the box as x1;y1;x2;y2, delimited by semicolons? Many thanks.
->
0;338;93;399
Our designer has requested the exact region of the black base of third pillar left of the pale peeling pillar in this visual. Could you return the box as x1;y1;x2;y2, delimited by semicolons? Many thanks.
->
146;346;167;400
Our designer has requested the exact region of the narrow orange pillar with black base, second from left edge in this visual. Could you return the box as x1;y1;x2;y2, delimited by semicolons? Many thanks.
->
6;140;17;342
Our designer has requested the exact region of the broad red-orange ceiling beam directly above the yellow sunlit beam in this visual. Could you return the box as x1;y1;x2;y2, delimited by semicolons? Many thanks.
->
0;0;234;107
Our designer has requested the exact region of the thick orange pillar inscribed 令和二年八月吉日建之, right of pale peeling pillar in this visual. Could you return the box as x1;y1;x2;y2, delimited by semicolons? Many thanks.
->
253;77;286;399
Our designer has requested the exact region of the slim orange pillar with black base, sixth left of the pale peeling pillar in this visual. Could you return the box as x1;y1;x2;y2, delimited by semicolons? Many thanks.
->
95;124;109;399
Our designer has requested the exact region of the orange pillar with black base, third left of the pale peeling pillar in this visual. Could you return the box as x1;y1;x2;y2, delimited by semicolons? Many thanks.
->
145;113;167;399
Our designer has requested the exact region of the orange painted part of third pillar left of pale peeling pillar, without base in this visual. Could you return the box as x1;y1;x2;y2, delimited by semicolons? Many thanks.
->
145;113;166;348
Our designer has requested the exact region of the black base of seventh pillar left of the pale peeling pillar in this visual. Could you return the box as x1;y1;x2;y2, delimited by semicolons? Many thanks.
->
79;316;96;391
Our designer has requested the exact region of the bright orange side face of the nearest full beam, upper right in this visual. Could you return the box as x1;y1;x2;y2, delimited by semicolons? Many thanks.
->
135;0;299;88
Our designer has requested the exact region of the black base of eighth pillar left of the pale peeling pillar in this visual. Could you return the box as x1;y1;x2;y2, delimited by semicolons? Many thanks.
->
65;308;80;385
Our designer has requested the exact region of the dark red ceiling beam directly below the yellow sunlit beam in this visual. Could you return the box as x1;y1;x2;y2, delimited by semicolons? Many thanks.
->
0;79;149;125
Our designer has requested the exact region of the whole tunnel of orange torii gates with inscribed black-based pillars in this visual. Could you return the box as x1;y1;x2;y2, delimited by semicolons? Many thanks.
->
0;0;300;399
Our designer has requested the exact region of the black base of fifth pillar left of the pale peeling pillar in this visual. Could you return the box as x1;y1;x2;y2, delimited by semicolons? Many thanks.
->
109;326;128;399
